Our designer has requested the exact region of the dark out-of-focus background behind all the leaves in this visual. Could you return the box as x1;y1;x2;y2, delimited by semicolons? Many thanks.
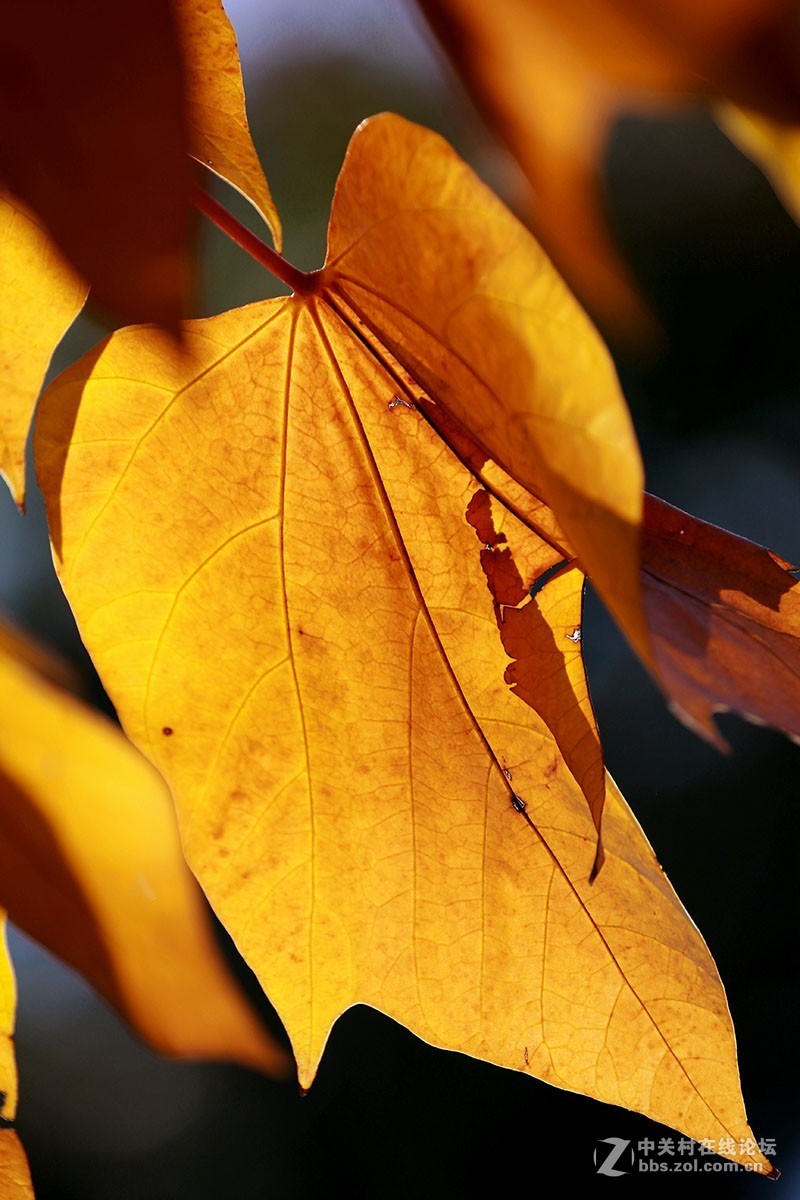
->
0;0;800;1200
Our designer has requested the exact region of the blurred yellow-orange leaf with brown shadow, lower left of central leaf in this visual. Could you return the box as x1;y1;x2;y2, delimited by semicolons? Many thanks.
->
0;633;288;1074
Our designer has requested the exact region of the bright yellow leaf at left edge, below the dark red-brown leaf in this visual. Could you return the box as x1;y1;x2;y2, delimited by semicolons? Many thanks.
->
0;194;86;506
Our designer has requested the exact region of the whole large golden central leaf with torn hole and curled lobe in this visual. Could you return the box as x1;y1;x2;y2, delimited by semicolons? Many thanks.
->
37;116;765;1166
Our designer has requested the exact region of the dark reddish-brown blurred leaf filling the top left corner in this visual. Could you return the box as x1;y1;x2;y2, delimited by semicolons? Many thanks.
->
0;0;192;329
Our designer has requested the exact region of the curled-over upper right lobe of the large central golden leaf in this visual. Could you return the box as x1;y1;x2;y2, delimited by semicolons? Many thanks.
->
320;118;648;659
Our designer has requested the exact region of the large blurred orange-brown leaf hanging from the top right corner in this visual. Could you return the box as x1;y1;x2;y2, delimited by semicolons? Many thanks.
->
420;0;800;341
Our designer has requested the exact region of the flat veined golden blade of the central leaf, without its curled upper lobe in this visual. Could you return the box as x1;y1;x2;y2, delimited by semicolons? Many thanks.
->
37;120;760;1163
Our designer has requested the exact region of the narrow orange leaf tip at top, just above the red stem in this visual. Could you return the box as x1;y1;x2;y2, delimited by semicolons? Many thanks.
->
175;0;281;250
